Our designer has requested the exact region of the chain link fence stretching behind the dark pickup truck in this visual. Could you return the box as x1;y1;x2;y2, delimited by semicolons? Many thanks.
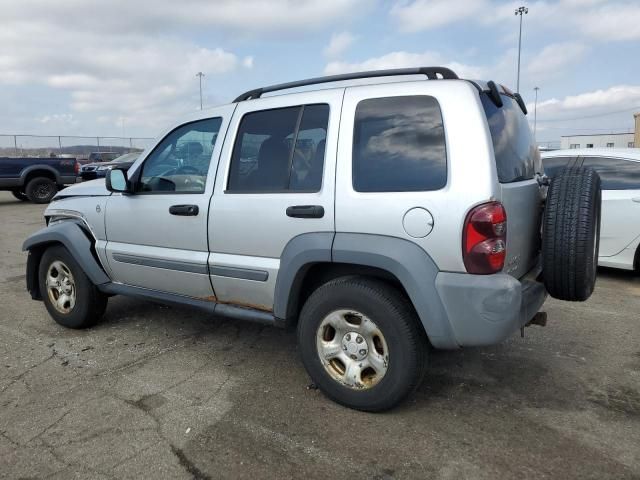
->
0;134;153;160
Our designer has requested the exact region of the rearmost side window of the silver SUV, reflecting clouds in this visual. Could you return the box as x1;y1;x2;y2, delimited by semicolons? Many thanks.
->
352;96;447;192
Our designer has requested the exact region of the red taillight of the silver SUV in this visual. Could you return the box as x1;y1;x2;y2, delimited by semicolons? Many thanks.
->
462;202;507;274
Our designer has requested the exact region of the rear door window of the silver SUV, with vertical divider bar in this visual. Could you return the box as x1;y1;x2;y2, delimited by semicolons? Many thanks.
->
227;104;329;193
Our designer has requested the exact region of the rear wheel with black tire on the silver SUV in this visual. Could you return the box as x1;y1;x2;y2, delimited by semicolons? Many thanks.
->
298;277;427;412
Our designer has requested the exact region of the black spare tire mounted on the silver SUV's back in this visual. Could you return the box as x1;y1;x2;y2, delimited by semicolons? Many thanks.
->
542;166;602;302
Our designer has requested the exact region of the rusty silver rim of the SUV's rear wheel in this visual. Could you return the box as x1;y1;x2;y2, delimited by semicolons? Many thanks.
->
316;310;389;390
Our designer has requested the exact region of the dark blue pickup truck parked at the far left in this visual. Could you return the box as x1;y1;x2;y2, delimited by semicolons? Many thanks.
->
0;157;80;203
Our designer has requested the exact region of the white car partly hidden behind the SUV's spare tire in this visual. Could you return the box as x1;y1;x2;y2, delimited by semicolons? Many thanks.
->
541;148;640;270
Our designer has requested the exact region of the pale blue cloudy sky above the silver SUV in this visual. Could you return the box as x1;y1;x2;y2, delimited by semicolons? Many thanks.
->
0;0;640;140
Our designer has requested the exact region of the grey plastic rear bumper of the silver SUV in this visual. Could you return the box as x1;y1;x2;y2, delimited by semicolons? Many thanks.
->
436;268;547;347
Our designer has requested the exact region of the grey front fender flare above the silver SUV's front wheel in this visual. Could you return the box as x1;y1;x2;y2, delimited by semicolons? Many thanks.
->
22;220;110;300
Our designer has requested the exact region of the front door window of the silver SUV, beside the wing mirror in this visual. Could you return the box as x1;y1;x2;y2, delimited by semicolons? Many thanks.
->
137;118;222;193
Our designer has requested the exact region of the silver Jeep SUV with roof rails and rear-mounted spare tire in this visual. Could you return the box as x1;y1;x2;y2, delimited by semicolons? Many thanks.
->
24;67;600;411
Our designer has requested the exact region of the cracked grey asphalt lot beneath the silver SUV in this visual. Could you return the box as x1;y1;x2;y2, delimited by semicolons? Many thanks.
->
0;192;640;480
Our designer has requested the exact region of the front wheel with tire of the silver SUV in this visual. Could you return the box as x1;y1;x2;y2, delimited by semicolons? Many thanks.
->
38;245;107;328
